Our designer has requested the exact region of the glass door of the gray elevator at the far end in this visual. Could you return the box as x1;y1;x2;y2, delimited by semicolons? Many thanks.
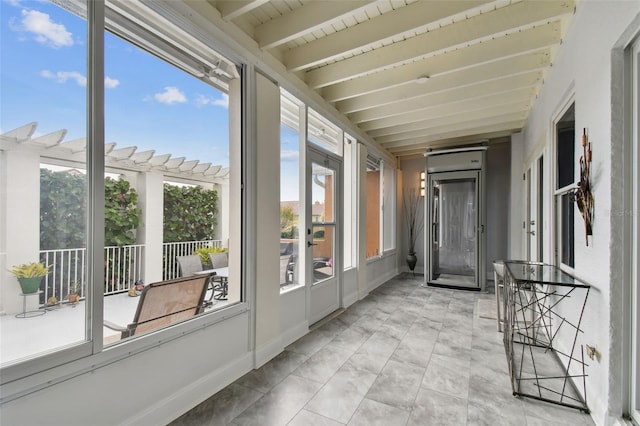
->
427;171;480;288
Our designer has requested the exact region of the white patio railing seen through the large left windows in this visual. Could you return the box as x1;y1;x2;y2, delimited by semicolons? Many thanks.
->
40;240;221;304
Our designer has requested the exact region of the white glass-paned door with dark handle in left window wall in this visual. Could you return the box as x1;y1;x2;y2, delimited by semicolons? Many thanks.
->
306;148;342;324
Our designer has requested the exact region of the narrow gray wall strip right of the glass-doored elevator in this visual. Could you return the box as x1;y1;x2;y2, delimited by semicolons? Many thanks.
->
486;141;511;277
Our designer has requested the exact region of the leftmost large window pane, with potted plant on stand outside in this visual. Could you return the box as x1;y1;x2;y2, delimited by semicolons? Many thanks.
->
0;1;89;367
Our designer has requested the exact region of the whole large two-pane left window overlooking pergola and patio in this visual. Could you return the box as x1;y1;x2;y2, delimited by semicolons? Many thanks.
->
0;1;242;376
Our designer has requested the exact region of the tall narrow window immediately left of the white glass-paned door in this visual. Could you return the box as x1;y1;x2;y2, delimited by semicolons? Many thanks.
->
280;91;305;291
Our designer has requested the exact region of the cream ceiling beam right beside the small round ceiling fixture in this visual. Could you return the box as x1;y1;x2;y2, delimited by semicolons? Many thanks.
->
322;22;560;102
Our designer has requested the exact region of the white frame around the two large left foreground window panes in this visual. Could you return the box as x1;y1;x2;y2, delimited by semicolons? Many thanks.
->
0;0;248;396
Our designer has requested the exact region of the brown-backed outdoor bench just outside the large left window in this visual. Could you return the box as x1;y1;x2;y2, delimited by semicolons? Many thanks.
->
104;275;210;339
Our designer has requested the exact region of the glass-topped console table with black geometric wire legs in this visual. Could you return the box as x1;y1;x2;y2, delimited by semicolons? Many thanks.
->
504;261;590;413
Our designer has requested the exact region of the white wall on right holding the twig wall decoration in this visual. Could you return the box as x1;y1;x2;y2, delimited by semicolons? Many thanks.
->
511;1;640;424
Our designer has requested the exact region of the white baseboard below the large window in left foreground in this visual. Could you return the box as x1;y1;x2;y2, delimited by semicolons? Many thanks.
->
127;352;253;426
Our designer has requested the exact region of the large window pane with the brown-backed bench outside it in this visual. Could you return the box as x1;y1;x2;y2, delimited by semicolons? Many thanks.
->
103;10;240;343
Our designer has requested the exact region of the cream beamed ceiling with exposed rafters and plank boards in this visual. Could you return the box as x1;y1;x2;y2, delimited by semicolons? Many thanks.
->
208;0;575;156
